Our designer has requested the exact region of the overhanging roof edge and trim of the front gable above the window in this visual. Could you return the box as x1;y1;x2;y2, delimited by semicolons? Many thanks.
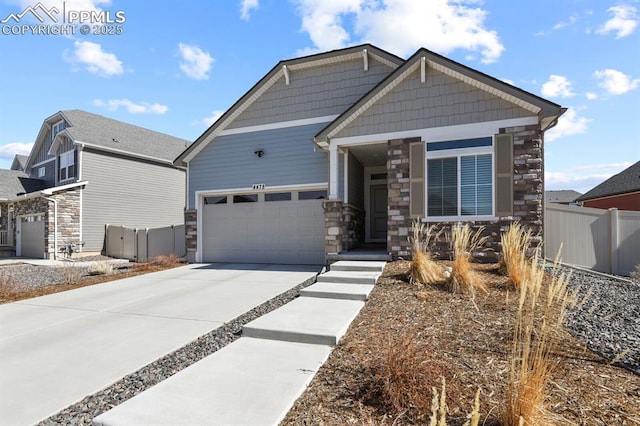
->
314;48;566;147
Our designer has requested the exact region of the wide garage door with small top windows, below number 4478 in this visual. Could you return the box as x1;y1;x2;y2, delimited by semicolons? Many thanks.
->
202;193;324;264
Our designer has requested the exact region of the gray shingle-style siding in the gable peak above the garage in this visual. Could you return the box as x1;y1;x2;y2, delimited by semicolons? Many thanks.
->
229;60;392;128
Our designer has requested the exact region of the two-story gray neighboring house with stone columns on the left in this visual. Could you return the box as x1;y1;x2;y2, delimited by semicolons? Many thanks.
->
0;110;188;258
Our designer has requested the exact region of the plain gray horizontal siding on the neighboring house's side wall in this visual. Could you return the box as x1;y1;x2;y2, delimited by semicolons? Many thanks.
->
82;150;185;251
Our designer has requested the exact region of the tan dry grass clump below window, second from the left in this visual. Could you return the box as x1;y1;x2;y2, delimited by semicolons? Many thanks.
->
446;223;487;296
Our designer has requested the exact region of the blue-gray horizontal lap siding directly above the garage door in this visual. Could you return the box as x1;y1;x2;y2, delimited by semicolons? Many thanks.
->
189;123;329;208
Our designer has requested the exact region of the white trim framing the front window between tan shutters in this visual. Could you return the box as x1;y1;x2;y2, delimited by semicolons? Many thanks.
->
422;143;498;223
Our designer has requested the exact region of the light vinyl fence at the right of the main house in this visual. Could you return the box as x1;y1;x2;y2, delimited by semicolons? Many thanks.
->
544;203;640;275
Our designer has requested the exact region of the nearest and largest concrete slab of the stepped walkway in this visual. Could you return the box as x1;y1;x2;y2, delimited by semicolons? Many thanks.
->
93;337;331;426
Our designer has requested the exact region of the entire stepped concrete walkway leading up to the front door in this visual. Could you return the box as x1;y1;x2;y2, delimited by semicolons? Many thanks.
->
94;261;385;426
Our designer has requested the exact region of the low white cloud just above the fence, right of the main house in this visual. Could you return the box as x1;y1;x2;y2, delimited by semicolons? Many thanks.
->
544;162;632;193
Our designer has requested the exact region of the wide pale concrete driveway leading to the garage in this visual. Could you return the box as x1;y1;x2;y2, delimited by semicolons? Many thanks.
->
0;264;320;425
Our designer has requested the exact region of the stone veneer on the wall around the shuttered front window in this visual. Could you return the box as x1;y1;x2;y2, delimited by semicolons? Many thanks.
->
387;125;544;261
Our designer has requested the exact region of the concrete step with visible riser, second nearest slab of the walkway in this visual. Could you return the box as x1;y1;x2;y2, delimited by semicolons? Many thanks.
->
242;297;364;346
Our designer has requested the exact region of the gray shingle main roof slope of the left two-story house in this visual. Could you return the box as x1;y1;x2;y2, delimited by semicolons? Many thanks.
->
62;109;189;161
